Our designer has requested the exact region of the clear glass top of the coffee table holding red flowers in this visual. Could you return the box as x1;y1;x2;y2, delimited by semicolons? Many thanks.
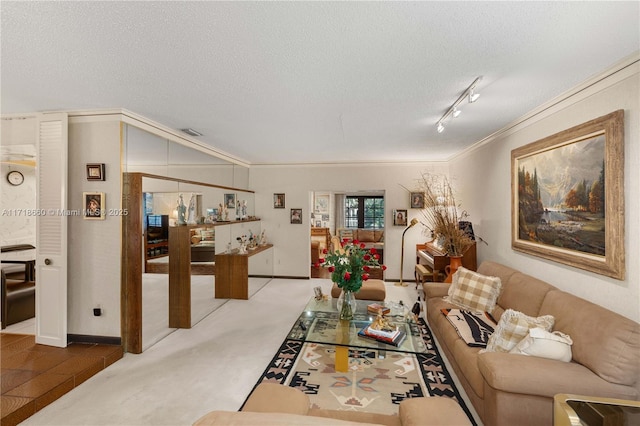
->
289;298;427;353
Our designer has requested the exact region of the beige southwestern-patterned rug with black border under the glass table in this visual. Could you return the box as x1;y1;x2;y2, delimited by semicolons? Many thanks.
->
245;318;476;425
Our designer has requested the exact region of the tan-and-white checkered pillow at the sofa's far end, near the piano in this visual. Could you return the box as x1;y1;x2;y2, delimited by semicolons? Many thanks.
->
449;267;502;312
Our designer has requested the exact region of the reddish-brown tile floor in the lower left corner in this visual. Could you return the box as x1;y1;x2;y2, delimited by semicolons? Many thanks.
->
0;333;123;426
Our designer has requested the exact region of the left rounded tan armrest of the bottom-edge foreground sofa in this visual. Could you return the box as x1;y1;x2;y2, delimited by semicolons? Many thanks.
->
242;382;310;415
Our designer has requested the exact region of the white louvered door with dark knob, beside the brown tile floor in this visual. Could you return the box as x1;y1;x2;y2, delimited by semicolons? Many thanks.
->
36;113;68;347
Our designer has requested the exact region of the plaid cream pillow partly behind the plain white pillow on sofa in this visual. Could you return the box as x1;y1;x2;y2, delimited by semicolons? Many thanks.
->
480;309;555;352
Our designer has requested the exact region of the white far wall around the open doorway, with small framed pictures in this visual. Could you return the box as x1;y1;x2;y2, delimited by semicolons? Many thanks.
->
249;163;448;281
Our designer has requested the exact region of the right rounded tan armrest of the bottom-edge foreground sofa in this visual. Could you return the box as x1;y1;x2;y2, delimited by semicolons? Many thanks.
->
398;396;471;426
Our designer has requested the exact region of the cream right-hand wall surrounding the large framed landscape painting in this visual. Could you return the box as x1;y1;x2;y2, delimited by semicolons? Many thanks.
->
451;63;640;321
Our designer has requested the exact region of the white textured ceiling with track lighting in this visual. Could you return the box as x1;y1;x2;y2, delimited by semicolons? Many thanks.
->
0;0;640;164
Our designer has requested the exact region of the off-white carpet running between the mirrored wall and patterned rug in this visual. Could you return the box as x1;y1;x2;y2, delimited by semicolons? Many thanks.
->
3;279;476;425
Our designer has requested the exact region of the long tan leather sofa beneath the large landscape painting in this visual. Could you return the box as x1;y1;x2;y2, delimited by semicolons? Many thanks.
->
423;262;640;426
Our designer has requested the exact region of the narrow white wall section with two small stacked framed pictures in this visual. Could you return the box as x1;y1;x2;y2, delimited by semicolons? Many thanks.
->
68;119;122;337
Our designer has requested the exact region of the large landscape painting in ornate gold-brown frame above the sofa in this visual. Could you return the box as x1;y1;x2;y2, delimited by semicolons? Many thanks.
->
511;110;625;280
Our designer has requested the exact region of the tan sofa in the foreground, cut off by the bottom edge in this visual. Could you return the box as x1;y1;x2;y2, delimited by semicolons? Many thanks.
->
194;382;471;426
